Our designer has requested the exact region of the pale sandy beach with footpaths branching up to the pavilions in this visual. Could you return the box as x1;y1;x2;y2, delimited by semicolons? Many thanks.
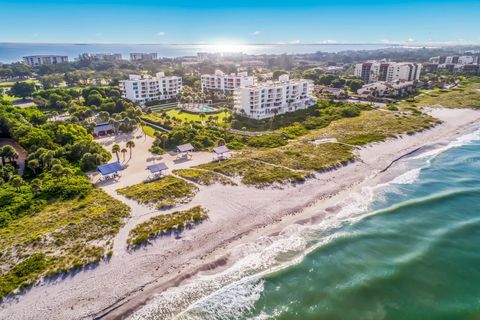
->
0;109;480;319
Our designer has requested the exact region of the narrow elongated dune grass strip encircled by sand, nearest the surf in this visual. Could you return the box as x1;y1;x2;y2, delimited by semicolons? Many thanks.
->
127;206;208;247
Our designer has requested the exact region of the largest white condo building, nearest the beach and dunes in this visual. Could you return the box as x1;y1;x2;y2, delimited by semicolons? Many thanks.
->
234;75;317;119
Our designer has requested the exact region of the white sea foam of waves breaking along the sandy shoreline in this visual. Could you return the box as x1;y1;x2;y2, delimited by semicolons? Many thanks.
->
131;126;480;320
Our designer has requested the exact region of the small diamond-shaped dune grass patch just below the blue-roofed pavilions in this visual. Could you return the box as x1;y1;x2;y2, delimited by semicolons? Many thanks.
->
117;175;198;209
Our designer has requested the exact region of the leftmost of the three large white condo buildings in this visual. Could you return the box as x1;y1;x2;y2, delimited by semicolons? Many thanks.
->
120;72;182;105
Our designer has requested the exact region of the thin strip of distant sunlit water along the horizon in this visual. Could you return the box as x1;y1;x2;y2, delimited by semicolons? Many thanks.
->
0;43;394;63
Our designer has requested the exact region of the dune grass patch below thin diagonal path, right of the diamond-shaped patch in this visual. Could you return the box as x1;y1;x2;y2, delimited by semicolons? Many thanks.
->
198;158;307;188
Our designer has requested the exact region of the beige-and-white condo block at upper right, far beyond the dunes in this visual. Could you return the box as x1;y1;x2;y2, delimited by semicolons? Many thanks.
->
354;61;422;83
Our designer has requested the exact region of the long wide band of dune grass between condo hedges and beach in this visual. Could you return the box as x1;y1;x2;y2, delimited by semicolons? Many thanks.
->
193;110;440;188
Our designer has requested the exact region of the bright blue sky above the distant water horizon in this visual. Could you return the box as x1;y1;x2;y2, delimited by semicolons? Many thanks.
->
0;0;480;44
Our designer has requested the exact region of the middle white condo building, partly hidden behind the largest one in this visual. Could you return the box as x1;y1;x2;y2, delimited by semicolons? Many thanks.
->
201;70;255;91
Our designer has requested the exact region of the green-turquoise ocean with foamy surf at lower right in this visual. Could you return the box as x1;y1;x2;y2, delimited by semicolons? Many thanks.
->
132;126;480;320
